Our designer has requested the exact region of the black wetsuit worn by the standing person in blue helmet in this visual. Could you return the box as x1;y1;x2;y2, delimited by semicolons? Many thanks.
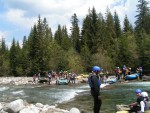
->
91;75;102;113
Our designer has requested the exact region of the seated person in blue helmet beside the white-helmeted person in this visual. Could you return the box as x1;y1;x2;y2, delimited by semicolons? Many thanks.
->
129;89;145;113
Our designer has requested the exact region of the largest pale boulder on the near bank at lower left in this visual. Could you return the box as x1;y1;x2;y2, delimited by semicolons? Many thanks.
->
6;99;25;113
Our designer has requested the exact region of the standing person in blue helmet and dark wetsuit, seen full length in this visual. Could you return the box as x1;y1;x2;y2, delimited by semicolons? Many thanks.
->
88;66;102;113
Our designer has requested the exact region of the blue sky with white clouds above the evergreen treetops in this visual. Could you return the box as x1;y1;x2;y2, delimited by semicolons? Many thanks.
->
0;0;142;47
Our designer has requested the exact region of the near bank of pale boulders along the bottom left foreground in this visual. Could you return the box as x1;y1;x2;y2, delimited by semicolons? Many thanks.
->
0;99;80;113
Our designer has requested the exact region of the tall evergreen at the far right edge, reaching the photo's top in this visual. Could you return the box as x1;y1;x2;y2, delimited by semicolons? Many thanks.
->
135;0;150;68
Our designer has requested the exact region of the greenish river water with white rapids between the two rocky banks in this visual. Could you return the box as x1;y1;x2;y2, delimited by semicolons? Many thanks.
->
0;82;150;113
